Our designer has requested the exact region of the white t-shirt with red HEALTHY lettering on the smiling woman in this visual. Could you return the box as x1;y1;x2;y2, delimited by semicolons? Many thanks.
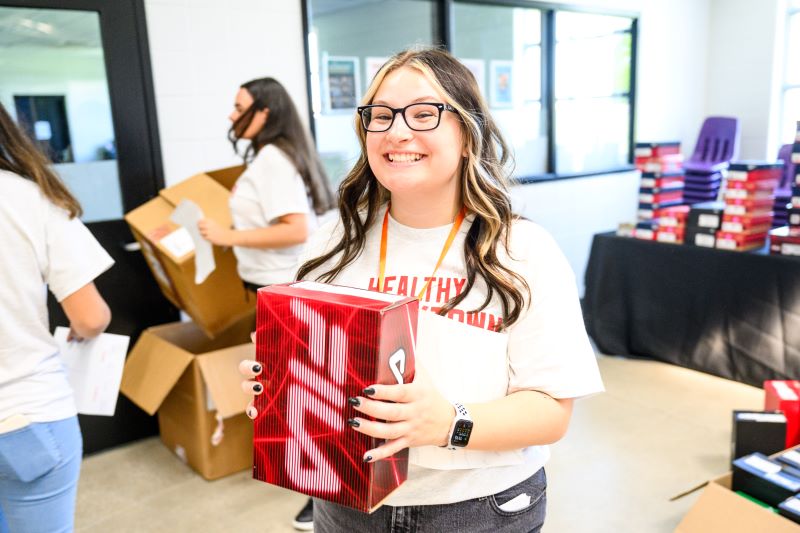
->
296;206;604;506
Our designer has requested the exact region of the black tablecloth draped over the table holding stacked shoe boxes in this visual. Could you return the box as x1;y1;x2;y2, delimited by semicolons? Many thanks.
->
583;233;800;386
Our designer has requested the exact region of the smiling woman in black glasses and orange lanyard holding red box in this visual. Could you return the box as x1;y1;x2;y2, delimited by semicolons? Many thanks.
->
240;48;603;533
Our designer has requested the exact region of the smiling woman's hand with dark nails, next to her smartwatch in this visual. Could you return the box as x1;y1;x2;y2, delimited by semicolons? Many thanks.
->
348;372;455;462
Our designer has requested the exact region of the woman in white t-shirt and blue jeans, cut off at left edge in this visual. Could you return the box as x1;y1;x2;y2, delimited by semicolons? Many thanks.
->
0;105;114;532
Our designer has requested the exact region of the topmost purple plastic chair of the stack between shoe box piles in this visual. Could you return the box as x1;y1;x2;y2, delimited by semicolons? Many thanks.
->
683;117;739;174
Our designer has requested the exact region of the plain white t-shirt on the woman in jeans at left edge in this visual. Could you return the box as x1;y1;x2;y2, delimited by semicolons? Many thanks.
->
0;170;114;422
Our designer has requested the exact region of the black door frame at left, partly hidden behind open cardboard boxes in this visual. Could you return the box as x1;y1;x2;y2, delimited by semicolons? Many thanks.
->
0;0;179;454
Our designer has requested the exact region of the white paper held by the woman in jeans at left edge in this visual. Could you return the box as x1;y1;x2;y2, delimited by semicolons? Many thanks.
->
53;327;130;416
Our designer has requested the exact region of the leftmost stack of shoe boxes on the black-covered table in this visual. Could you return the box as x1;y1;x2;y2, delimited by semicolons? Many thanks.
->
633;141;685;242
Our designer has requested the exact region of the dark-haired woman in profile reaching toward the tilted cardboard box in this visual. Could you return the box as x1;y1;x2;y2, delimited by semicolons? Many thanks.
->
198;78;335;290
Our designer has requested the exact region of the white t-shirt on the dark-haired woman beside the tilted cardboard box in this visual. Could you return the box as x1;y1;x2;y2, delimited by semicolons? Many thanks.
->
230;144;317;285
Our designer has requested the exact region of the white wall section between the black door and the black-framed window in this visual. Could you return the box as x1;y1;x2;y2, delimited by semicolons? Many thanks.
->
145;0;308;185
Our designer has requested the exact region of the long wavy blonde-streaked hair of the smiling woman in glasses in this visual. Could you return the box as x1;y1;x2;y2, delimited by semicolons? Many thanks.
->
297;48;530;329
